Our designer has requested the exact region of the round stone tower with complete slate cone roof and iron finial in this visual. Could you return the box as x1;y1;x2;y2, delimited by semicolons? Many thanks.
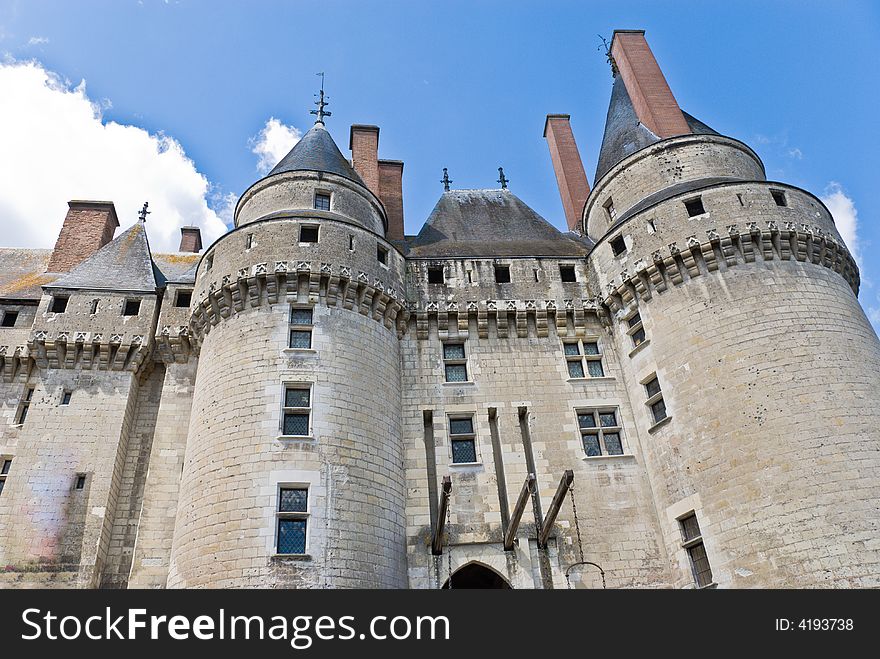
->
168;115;406;588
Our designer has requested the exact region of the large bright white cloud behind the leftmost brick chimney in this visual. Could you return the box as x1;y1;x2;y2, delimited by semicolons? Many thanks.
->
0;58;229;252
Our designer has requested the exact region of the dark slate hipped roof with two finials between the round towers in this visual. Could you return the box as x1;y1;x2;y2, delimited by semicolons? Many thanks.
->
407;190;590;258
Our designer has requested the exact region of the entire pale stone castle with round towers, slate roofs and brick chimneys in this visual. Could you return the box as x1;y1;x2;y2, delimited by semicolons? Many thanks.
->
0;31;880;588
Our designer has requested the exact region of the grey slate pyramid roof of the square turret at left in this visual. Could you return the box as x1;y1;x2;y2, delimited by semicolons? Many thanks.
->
46;222;156;293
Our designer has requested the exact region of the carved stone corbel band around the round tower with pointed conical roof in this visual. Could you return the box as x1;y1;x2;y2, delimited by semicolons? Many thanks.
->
188;261;409;351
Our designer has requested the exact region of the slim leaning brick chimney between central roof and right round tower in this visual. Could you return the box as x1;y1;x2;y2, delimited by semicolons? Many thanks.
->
544;114;590;231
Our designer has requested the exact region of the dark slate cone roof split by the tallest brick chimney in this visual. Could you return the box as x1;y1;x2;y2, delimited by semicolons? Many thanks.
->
593;76;718;186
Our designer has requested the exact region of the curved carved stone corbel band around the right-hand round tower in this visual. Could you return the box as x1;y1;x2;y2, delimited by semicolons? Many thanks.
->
603;220;859;312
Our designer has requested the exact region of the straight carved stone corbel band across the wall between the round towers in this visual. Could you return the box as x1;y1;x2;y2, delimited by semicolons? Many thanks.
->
410;298;610;340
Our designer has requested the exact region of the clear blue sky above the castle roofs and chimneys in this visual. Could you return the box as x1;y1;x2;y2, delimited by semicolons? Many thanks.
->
0;0;880;326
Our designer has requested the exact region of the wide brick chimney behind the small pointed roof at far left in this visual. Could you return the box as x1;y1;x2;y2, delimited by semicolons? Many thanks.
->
46;200;119;272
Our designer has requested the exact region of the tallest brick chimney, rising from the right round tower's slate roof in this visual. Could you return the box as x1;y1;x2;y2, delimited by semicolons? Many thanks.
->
611;30;691;138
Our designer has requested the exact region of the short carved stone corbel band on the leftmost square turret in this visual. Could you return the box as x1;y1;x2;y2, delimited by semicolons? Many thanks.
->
27;330;152;371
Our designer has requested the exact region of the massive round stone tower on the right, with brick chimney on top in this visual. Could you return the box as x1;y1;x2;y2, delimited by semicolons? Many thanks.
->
583;32;880;587
